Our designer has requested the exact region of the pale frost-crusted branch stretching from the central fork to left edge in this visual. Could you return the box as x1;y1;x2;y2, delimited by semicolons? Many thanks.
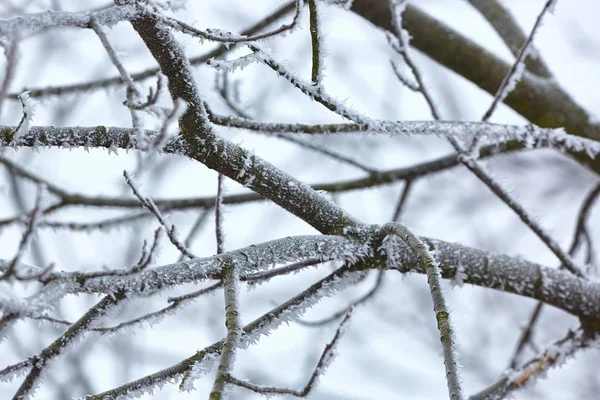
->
0;236;371;317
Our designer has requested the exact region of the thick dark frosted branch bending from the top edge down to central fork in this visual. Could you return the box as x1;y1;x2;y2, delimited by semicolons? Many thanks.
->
132;16;361;234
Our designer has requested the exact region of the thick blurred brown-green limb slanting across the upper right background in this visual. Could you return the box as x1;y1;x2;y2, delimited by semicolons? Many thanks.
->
351;0;600;173
